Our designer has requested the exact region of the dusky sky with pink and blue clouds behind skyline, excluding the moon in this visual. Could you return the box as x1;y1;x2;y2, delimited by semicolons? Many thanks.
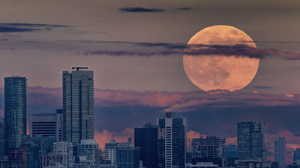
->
0;0;300;163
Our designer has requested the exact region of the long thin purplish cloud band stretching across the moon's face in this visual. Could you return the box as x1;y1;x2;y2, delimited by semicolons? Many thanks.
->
78;42;300;60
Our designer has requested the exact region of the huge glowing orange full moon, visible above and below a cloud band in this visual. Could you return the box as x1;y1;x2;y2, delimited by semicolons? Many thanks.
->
183;25;259;91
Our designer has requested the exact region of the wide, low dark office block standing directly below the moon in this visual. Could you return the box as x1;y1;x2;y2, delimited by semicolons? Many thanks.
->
192;136;226;167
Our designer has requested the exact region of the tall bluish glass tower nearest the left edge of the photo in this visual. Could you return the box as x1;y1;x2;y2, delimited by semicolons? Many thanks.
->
4;76;27;159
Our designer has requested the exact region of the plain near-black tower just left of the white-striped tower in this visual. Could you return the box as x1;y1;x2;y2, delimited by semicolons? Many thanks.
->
134;123;158;168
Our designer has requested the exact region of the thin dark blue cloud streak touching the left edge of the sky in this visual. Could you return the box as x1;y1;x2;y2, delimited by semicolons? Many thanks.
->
0;23;68;33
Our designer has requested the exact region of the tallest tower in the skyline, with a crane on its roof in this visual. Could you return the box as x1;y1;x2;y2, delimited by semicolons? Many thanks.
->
63;67;94;148
